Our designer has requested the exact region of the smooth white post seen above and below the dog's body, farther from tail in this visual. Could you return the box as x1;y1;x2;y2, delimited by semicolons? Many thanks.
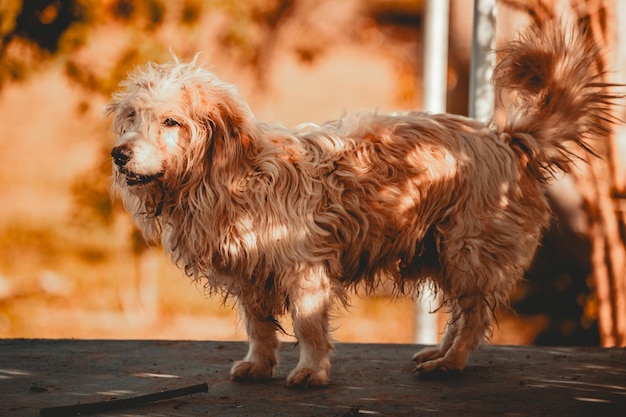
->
415;0;450;345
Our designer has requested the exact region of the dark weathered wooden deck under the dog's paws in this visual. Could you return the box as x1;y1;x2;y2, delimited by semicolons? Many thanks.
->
0;339;626;417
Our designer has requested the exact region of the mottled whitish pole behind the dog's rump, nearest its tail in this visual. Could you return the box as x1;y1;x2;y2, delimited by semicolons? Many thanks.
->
469;0;497;122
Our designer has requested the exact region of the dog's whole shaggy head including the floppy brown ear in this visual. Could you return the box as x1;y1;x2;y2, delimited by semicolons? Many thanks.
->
104;60;254;203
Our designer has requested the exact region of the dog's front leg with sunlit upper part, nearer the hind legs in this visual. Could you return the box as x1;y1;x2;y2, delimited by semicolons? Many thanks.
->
287;267;333;388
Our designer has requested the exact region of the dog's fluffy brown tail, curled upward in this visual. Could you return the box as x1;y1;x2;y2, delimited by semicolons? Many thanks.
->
493;21;618;181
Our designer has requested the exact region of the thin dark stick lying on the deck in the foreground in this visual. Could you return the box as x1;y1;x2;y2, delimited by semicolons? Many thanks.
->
39;383;209;417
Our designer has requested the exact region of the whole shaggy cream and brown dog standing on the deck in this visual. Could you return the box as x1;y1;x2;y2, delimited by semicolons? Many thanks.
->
106;23;615;387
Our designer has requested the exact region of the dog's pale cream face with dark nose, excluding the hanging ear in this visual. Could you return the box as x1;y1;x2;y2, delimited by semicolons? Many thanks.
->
105;64;202;187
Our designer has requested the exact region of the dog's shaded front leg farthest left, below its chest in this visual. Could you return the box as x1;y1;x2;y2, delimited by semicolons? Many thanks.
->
230;301;278;381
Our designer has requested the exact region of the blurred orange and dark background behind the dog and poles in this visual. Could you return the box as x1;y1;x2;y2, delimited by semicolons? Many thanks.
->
0;0;626;346
